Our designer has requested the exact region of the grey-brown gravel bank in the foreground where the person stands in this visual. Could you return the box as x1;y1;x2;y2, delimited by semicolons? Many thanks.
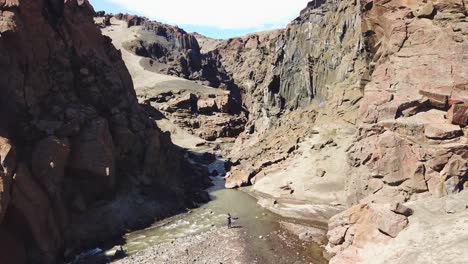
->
115;223;325;264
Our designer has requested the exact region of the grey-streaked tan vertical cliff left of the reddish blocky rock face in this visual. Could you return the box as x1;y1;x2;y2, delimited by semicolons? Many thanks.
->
224;1;370;190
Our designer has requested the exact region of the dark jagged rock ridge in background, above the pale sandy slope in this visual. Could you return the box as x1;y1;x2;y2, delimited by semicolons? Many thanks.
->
107;14;240;110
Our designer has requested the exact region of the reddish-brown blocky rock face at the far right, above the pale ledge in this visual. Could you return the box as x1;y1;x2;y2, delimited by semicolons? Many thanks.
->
350;1;468;204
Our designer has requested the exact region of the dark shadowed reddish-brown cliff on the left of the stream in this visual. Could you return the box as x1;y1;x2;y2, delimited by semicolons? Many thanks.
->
0;0;208;263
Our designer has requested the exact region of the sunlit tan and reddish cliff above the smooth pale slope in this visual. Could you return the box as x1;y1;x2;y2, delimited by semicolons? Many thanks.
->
223;1;467;193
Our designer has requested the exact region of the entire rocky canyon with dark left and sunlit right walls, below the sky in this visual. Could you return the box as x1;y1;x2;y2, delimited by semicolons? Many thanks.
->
0;0;468;263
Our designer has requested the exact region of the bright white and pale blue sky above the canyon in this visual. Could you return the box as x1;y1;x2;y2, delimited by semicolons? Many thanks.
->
89;0;310;39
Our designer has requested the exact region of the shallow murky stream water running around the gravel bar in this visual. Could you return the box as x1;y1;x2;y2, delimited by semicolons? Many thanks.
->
110;161;326;263
